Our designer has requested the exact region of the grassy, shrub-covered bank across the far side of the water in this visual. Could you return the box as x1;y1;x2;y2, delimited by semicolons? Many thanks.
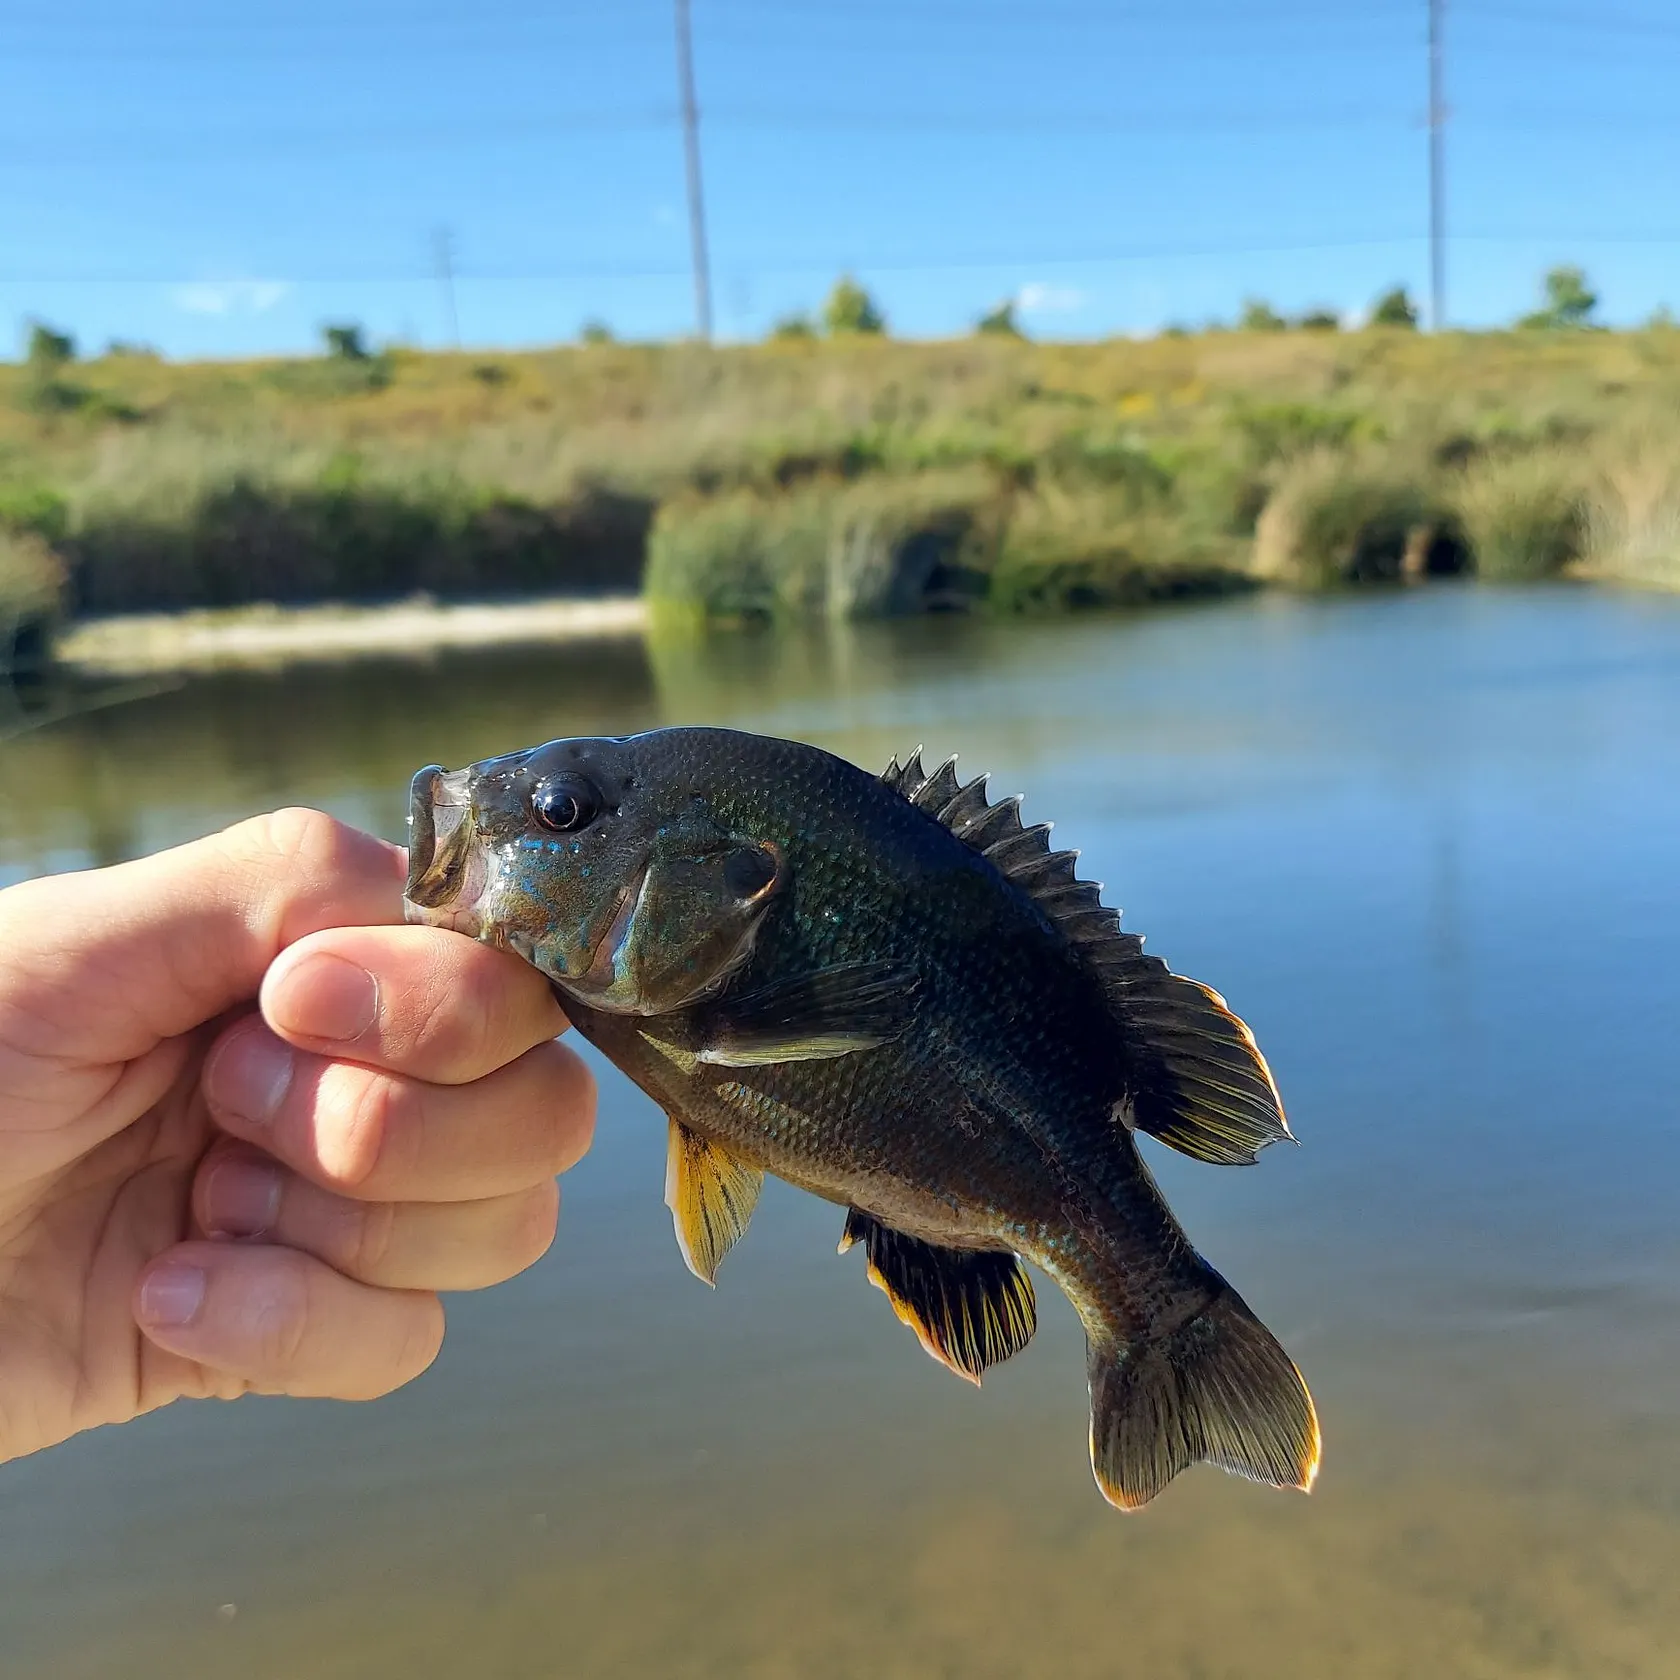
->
0;328;1680;635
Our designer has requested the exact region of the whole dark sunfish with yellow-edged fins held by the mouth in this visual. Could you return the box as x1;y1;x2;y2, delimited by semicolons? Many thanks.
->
405;727;1322;1510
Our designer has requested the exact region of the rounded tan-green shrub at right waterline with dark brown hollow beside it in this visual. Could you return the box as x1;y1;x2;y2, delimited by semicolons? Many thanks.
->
1255;450;1457;588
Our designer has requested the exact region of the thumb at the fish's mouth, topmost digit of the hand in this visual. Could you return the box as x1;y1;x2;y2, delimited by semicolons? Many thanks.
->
0;810;407;1062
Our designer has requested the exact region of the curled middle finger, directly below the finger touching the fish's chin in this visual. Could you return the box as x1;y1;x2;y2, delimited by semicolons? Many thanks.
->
203;1016;595;1201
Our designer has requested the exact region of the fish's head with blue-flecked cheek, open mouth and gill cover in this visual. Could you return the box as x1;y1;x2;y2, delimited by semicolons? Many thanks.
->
405;736;786;1015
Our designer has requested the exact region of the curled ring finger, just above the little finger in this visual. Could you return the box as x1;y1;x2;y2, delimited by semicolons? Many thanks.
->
193;1141;559;1290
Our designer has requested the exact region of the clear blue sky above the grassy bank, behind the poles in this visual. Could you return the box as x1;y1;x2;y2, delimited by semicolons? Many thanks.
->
0;0;1680;356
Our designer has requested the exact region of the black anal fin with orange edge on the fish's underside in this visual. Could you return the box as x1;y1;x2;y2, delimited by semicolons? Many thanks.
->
840;1208;1038;1386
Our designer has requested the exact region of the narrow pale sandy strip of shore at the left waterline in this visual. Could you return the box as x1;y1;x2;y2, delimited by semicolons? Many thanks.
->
54;595;647;675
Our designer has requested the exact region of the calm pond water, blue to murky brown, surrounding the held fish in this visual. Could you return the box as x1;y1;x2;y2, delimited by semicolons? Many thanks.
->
0;590;1680;1680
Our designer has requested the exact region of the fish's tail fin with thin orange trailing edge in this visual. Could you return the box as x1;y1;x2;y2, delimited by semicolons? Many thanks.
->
1090;1278;1320;1510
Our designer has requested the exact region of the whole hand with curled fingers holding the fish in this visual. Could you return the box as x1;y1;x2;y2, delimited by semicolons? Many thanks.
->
0;811;595;1462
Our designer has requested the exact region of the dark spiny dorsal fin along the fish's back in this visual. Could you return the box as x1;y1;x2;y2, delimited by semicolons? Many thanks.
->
880;748;1292;1166
